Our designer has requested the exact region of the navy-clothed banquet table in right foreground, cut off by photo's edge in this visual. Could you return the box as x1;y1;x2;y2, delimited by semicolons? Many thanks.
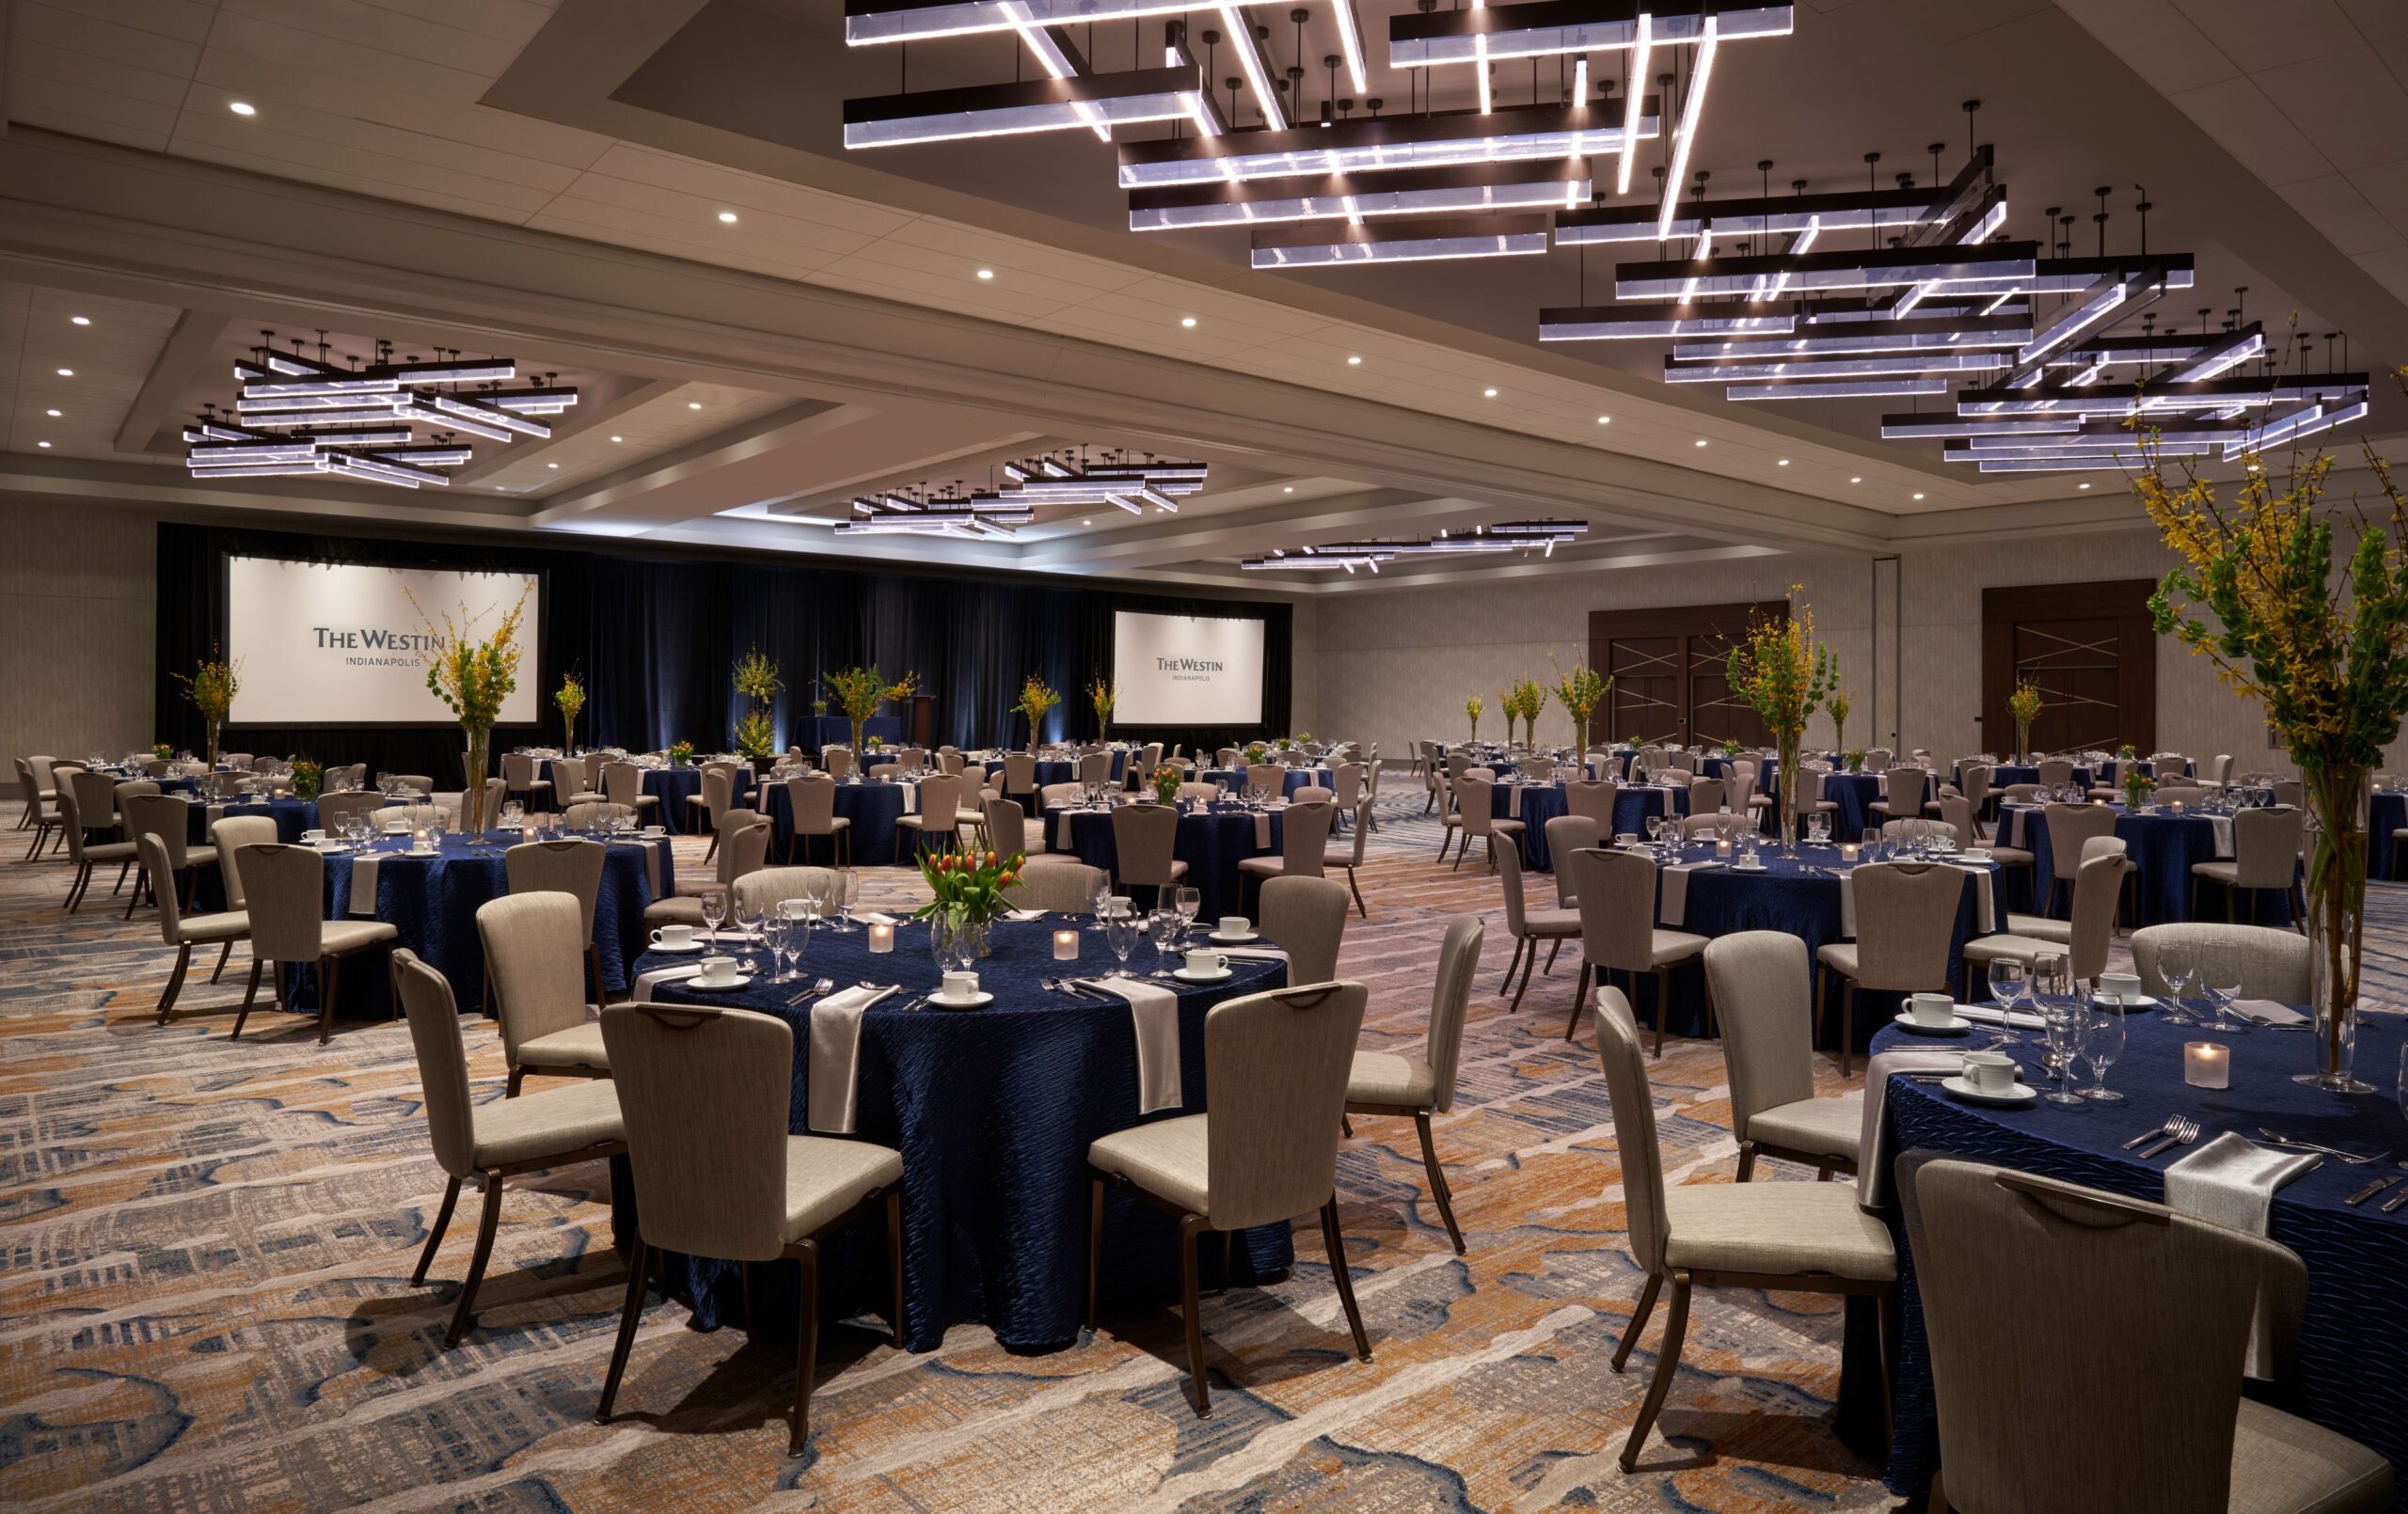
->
1840;1014;2408;1506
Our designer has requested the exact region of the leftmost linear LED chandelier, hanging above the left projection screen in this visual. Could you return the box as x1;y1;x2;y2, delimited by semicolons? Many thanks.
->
183;330;578;489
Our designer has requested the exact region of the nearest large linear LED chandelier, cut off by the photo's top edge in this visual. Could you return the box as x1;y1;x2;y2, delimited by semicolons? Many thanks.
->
846;0;1794;267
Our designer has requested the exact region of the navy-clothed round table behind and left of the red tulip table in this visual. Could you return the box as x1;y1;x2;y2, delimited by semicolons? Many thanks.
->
268;833;676;1018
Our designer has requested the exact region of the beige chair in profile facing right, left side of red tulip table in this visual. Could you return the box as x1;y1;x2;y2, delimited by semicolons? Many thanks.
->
392;948;626;1350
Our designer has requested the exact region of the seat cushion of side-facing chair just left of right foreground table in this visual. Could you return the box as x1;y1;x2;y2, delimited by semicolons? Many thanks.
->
1664;1182;1897;1283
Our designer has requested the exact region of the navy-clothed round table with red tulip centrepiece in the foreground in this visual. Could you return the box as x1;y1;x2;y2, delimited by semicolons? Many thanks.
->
611;915;1293;1350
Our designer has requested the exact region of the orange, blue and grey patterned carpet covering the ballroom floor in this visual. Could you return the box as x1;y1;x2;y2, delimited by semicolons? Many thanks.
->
0;795;2408;1511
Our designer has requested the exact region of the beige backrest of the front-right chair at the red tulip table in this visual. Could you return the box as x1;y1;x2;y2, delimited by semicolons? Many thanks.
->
1204;982;1370;1230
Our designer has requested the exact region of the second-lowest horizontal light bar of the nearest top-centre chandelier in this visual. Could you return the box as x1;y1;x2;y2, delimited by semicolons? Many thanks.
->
1130;159;1592;231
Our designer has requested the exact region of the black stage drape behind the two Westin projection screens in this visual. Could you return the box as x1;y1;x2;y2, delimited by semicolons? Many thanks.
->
154;522;1293;784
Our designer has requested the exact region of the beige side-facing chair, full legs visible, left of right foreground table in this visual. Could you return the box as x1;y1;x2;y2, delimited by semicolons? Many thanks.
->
1596;989;1897;1473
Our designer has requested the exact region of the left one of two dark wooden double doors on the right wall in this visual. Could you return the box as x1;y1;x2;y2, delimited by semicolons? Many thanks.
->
1590;599;1789;746
